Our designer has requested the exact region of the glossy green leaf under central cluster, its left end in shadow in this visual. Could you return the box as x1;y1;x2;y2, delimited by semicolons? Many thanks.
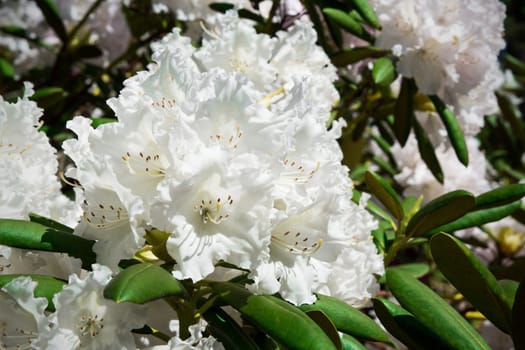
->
211;282;336;350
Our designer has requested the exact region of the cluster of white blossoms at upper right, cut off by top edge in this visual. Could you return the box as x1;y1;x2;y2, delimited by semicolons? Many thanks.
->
371;0;505;139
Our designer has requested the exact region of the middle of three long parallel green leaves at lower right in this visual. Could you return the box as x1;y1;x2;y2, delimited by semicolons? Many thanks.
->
386;269;490;350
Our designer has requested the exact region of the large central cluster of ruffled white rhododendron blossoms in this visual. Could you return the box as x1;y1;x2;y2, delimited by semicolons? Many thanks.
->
63;12;383;305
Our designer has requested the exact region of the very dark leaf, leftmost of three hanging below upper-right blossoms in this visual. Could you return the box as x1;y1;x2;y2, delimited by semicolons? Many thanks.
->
393;78;417;146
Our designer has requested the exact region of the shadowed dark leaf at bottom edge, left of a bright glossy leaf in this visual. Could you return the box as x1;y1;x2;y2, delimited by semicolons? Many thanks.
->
203;307;259;350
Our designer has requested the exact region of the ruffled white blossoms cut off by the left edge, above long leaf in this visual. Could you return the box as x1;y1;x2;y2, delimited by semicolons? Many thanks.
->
0;83;79;225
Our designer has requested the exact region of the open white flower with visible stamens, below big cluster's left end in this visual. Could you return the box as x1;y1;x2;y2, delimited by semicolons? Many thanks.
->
35;264;144;349
